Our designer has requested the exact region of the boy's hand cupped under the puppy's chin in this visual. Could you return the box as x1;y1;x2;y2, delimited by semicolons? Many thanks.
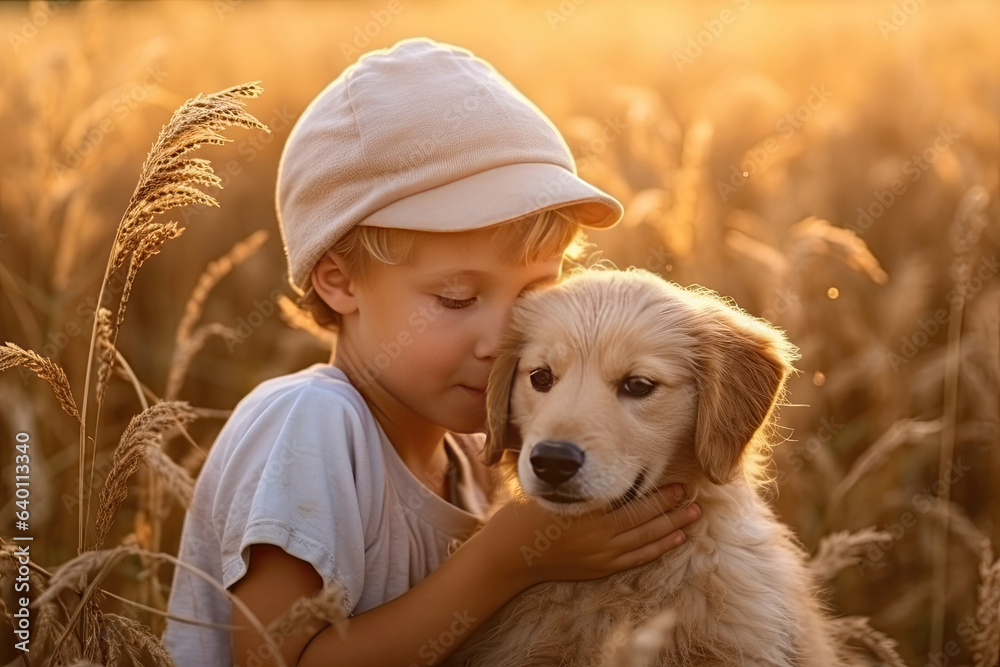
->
477;484;701;588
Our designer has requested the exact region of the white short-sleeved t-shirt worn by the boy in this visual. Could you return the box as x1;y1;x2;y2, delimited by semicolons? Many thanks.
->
163;364;490;667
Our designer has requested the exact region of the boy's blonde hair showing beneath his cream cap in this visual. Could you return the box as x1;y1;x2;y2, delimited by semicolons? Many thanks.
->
298;209;592;331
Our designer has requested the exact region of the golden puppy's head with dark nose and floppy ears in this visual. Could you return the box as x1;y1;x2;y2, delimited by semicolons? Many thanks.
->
487;269;795;513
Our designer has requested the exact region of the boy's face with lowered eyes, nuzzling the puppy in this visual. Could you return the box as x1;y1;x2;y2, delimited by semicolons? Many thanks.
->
338;230;561;433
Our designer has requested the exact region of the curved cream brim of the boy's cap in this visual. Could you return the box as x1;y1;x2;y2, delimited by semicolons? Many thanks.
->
358;163;623;232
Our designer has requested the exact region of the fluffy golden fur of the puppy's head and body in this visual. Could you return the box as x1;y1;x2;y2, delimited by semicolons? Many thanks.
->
452;269;849;667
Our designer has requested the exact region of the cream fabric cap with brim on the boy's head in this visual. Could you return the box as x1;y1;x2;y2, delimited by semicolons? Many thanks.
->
276;38;623;294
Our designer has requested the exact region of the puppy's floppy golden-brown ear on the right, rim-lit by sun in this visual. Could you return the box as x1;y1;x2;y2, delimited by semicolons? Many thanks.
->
695;316;793;484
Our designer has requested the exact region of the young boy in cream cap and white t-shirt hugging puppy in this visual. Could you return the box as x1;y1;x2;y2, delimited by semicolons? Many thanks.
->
164;39;696;667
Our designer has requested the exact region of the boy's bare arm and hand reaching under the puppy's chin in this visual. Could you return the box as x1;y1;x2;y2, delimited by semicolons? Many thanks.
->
232;492;695;667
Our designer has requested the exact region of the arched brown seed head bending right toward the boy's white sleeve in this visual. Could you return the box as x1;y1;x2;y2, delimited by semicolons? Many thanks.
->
96;401;195;549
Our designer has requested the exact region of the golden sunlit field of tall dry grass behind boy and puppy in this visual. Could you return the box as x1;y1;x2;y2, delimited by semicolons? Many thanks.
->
0;0;1000;667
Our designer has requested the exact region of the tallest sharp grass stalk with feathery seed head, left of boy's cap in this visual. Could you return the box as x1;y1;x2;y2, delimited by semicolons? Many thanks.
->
77;82;270;553
